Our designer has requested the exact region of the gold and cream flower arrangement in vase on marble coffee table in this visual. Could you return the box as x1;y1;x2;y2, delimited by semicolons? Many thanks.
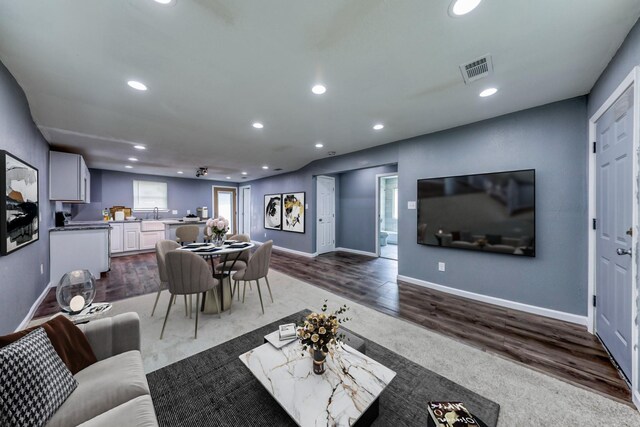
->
298;300;350;375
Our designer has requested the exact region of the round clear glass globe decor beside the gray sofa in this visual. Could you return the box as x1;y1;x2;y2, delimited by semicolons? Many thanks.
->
56;270;96;314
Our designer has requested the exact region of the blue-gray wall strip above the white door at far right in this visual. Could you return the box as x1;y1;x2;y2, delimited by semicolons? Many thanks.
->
587;20;640;119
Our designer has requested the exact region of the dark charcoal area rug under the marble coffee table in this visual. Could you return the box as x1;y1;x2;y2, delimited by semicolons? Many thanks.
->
147;310;500;427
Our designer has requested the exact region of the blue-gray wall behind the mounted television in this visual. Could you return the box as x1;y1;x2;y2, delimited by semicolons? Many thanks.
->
398;97;588;315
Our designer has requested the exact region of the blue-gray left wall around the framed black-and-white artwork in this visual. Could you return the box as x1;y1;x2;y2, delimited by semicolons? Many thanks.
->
0;63;53;335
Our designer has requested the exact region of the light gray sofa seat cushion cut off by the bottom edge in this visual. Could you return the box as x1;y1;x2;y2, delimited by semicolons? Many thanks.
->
80;395;158;427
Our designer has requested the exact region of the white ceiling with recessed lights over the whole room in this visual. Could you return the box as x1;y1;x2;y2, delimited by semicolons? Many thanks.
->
0;0;640;181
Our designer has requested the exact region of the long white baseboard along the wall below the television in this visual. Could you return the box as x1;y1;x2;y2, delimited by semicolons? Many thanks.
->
398;275;587;326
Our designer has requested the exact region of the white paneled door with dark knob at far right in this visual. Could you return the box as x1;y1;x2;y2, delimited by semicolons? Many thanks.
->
595;87;633;378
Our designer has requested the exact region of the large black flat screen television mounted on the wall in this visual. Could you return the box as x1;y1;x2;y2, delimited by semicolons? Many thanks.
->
417;169;536;257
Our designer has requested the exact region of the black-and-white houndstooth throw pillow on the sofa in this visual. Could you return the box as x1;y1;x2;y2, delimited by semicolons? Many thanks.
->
0;328;78;426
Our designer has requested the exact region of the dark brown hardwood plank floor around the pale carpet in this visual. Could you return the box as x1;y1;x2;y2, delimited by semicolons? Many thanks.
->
34;250;631;404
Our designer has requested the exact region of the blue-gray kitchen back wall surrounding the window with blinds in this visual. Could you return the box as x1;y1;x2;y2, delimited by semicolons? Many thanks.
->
69;169;237;221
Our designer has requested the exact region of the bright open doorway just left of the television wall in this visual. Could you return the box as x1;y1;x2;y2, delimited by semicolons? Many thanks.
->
375;173;399;261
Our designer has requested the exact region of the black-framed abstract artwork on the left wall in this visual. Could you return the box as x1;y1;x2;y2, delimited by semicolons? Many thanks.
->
0;150;40;255
